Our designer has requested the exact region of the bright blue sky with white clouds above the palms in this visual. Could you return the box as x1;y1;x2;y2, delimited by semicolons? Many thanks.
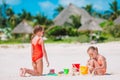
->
0;0;120;19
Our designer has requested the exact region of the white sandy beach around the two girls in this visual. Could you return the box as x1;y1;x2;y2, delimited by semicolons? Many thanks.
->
0;42;120;80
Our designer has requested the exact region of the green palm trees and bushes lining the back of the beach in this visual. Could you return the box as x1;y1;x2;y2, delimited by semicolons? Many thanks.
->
0;0;120;43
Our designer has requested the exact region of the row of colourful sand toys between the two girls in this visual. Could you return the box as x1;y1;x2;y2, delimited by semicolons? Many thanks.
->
46;64;88;76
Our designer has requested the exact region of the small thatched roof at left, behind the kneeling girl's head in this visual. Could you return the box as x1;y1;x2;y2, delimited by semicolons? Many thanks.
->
12;21;33;34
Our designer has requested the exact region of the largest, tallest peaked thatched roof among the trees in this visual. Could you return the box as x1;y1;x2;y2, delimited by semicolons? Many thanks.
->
53;3;91;26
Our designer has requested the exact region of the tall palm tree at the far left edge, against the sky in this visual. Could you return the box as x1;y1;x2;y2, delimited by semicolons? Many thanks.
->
0;0;18;28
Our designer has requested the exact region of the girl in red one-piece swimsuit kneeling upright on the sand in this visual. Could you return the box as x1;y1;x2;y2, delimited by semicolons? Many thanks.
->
20;26;49;77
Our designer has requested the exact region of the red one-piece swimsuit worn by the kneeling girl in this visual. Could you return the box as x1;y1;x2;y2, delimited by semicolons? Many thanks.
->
32;39;43;62
